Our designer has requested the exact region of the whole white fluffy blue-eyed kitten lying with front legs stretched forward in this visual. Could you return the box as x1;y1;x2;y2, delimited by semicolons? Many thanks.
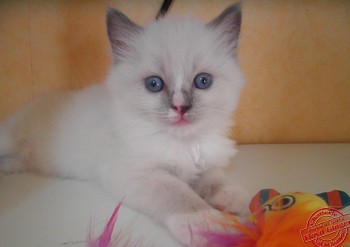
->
0;5;247;246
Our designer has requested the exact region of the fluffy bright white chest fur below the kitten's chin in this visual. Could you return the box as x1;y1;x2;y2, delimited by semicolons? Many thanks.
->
135;135;235;181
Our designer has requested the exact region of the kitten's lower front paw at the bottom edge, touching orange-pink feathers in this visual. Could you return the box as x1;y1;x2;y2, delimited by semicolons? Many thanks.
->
165;209;235;247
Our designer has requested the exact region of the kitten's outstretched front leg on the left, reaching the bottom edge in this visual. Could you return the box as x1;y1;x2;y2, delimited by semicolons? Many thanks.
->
102;168;232;246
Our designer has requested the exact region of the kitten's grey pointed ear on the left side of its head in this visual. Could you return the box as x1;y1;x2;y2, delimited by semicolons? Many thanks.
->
106;7;143;63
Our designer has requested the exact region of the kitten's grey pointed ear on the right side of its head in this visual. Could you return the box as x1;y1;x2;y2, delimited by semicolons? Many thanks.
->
207;3;242;52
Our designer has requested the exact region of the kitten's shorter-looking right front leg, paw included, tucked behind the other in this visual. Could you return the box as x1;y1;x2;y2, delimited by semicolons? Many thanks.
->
193;168;250;215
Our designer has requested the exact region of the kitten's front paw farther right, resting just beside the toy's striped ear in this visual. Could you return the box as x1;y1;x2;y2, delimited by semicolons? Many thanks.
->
207;185;250;216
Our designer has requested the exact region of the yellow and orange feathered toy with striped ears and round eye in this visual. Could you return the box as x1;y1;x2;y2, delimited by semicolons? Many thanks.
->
204;189;350;247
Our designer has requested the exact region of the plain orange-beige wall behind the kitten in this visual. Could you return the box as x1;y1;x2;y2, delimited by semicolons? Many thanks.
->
0;0;350;143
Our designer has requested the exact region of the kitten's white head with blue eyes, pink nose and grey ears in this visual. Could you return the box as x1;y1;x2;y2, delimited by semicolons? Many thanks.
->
107;5;243;136
